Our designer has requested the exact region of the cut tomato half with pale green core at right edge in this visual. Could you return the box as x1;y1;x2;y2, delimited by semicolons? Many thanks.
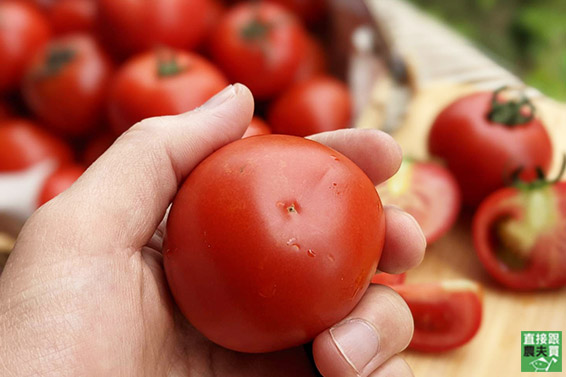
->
473;163;566;290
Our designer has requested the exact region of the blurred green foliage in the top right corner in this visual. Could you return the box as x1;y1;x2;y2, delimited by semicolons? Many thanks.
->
411;0;566;100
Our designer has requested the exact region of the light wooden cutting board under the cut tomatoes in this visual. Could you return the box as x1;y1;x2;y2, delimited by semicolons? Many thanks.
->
374;85;566;377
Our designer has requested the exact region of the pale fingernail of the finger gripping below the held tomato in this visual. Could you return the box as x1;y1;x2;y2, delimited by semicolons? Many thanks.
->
330;319;379;374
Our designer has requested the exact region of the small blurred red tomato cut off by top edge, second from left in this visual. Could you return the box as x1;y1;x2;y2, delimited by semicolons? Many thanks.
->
47;0;96;34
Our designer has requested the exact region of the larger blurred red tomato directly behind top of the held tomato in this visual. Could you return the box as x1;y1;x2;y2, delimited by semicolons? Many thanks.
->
268;76;352;136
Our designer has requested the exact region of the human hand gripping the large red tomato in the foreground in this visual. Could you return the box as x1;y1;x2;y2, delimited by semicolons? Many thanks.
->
0;85;425;377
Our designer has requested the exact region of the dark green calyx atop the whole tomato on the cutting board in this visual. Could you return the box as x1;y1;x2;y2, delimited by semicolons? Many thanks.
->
487;87;535;127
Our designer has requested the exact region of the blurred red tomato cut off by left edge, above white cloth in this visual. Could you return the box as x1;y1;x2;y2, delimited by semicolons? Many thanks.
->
0;119;73;172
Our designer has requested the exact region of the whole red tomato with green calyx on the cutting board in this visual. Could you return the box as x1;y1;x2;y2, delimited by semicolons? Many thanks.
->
428;88;552;207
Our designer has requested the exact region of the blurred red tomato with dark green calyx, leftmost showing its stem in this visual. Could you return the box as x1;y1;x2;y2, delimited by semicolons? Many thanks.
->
23;34;112;136
